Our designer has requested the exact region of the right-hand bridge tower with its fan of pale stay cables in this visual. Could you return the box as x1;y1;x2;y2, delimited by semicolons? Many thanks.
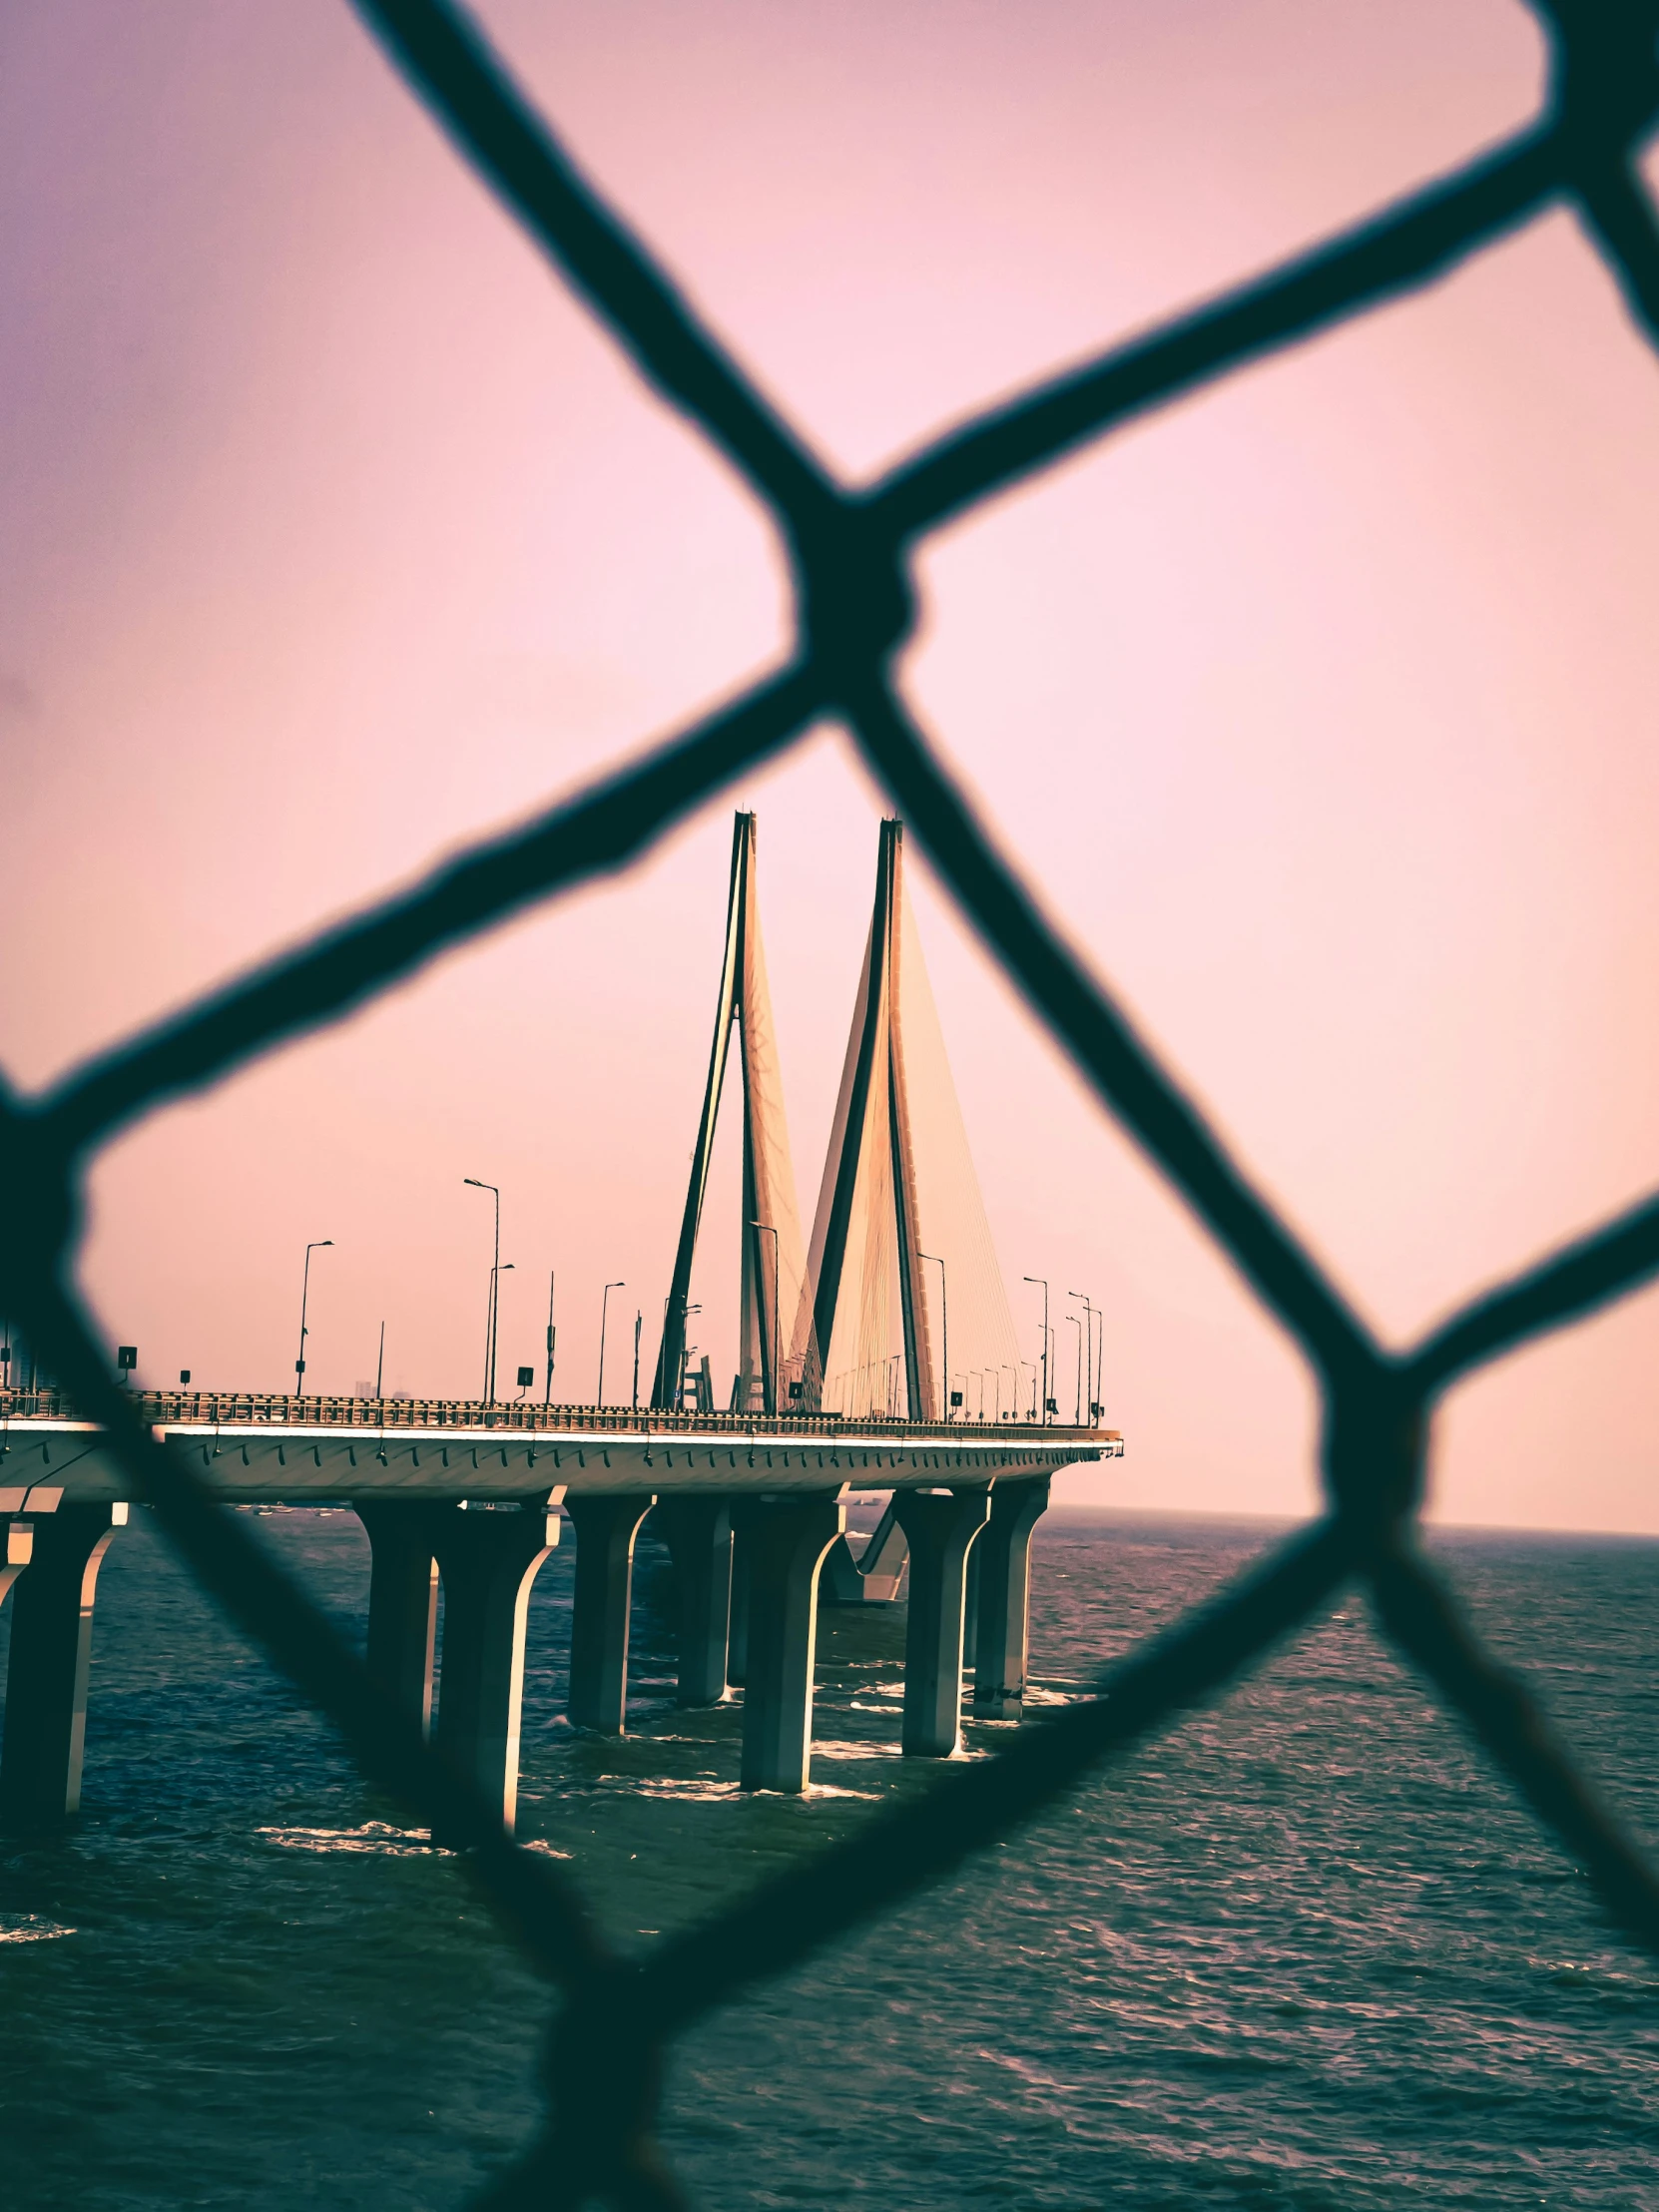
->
810;821;1017;1420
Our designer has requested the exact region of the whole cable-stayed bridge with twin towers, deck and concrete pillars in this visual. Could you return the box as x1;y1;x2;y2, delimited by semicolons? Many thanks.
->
0;814;1124;1832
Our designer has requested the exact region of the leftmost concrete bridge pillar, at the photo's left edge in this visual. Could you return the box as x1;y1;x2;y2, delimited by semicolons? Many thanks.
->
0;1504;126;1834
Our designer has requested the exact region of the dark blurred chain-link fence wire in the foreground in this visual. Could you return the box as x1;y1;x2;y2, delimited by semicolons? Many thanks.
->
0;0;1659;2208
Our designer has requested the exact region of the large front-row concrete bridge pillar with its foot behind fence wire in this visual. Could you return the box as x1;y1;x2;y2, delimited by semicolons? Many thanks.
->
429;1502;560;1834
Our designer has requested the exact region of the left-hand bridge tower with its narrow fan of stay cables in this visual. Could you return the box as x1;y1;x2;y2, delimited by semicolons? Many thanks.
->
651;814;806;1413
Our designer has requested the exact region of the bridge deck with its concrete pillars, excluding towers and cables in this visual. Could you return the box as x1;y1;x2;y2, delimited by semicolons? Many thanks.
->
0;1391;1124;1832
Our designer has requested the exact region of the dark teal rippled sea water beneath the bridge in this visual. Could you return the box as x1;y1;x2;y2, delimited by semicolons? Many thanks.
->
0;1511;1659;2212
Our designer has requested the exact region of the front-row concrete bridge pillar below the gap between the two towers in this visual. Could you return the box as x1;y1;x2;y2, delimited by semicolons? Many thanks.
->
741;1486;847;1792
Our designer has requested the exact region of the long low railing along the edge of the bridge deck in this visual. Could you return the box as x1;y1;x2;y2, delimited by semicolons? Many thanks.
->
0;1389;1119;1446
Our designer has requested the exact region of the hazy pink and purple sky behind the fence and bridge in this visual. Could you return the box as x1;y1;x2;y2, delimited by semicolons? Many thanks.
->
0;0;1659;1530
